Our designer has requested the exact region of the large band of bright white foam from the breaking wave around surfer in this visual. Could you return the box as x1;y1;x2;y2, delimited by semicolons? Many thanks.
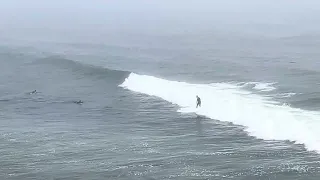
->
120;73;320;152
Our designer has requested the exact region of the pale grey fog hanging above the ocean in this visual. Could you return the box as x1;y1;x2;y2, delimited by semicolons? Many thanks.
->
0;0;320;43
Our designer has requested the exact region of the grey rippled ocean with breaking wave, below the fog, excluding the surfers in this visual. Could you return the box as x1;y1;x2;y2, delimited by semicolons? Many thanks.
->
0;33;320;180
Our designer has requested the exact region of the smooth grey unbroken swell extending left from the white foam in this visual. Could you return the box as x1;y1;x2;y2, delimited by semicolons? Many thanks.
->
0;45;130;83
